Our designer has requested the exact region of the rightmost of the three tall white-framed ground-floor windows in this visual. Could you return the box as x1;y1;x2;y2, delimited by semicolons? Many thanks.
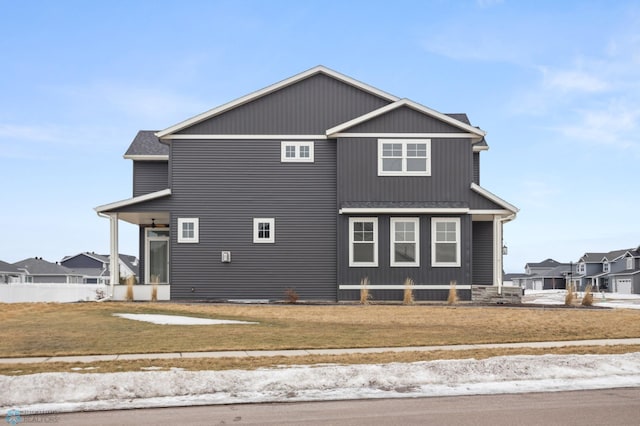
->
431;217;460;267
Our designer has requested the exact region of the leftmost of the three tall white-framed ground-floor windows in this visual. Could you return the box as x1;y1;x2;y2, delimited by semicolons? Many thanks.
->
349;217;378;267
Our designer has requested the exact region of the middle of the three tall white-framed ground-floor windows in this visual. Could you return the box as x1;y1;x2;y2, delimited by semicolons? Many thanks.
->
389;217;420;266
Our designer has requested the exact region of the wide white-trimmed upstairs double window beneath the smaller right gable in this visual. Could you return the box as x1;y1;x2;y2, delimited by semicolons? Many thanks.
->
378;139;431;176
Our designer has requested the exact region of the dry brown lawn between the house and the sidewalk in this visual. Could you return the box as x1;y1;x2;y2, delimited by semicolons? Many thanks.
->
0;302;640;357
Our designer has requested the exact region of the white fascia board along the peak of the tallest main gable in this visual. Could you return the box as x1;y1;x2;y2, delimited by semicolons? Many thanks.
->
155;65;399;139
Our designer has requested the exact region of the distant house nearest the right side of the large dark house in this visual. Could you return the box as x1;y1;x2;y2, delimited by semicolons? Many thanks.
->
512;259;572;290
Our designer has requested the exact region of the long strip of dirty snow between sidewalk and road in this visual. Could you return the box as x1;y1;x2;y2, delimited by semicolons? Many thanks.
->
0;353;640;412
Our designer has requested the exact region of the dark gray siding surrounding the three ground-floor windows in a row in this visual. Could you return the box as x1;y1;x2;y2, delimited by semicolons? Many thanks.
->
338;215;472;300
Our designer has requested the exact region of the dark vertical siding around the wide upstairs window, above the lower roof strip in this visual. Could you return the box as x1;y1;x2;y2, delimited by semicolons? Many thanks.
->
337;138;472;203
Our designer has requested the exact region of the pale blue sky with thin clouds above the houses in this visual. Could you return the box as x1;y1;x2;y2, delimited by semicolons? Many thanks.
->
0;0;640;272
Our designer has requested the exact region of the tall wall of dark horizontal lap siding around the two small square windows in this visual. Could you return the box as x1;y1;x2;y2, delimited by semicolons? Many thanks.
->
171;140;337;300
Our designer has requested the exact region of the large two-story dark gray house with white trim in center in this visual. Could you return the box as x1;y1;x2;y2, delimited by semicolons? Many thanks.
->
96;66;518;301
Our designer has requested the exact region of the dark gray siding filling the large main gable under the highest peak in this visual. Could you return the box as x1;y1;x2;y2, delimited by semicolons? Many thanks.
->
179;74;390;135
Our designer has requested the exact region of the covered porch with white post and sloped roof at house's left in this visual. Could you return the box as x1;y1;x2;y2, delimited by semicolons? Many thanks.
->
95;189;171;300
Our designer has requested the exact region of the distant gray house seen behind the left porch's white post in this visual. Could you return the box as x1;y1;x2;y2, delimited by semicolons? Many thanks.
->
60;252;138;284
